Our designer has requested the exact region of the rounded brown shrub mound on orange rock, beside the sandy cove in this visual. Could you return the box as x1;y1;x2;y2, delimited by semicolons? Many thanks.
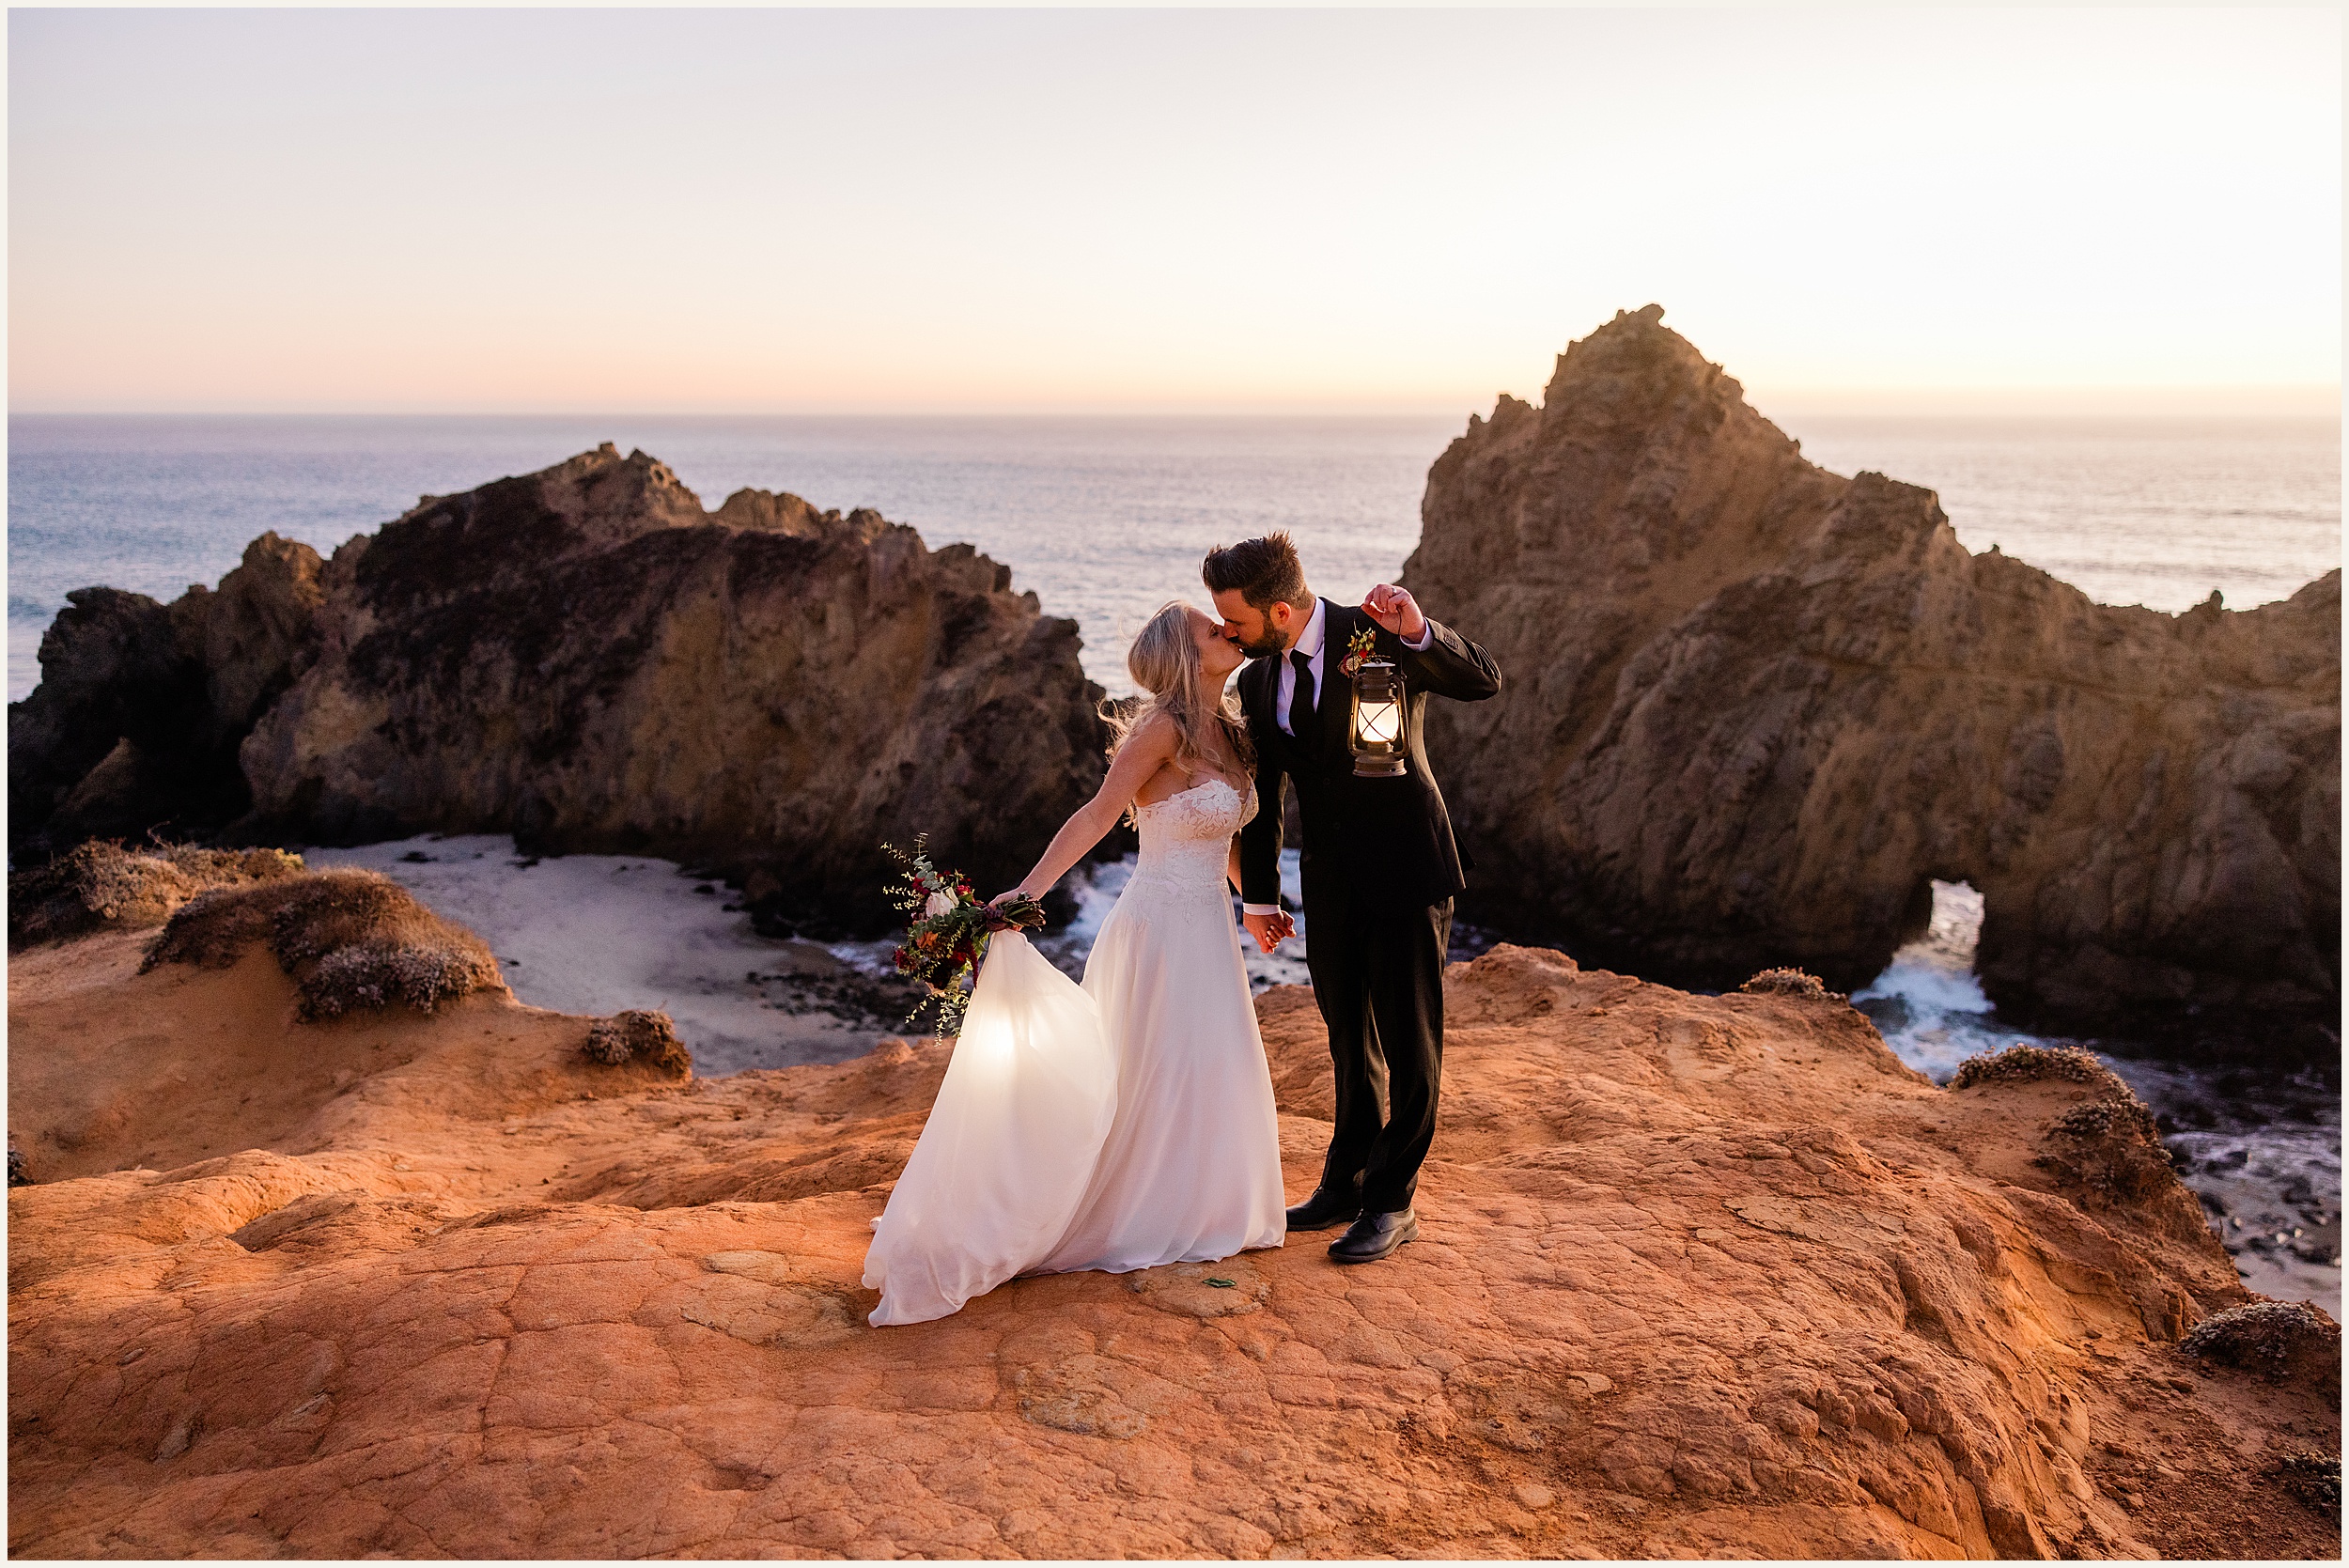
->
141;868;498;1023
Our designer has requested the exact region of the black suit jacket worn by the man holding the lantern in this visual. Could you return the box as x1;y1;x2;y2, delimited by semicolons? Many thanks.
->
1240;598;1501;913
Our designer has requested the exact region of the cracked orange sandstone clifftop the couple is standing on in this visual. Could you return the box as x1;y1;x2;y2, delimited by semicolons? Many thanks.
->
9;932;2340;1557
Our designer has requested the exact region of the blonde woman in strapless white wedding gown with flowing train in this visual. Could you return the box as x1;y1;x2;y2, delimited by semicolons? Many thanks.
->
864;601;1285;1327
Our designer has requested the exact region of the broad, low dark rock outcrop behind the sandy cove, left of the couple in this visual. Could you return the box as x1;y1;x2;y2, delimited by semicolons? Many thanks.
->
9;446;1104;927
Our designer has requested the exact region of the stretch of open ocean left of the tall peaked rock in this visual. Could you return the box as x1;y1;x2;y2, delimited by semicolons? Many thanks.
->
8;415;1459;700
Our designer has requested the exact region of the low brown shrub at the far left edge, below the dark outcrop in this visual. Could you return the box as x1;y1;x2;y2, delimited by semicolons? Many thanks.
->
8;838;303;953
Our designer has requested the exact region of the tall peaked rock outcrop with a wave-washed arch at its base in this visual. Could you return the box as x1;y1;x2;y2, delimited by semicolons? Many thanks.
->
1405;305;2340;1023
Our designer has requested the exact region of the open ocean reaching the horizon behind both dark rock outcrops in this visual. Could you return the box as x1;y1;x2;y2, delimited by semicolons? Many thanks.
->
8;413;2342;700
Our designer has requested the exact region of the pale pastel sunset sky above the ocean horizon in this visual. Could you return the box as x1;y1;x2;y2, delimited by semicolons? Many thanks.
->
9;9;2342;413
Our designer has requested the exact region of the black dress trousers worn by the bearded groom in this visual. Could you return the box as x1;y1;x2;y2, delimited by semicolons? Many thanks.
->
1306;896;1452;1214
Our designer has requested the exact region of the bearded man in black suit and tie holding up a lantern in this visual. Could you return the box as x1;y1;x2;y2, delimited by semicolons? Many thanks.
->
1201;533;1501;1263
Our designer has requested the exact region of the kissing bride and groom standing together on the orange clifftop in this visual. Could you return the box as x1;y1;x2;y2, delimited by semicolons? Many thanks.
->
864;533;1501;1324
